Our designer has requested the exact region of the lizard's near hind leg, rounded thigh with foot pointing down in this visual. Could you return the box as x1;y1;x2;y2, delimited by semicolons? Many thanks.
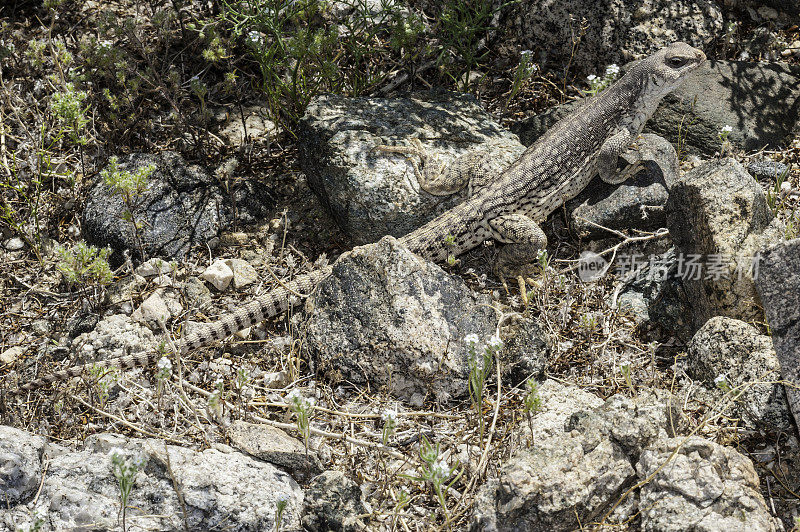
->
489;214;547;306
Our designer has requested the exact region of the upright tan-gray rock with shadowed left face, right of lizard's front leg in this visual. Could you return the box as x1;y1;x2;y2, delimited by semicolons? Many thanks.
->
666;159;783;329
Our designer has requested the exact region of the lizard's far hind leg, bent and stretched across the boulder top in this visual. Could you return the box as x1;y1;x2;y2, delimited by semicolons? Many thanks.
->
373;138;497;196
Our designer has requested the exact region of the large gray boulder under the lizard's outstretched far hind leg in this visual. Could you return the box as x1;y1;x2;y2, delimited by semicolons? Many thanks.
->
298;93;524;244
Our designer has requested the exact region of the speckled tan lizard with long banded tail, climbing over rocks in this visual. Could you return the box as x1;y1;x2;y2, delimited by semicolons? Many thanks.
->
6;42;705;396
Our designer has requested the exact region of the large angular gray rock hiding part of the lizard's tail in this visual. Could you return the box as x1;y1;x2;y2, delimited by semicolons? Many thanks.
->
306;237;496;405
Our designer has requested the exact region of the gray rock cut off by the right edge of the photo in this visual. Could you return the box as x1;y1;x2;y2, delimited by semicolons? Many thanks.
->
756;238;800;425
